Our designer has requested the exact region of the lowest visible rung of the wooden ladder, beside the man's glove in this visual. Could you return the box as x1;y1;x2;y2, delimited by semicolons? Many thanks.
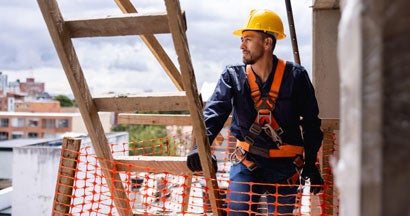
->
115;156;192;175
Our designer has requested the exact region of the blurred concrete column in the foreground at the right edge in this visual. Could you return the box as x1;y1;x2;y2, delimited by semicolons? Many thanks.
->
335;0;410;216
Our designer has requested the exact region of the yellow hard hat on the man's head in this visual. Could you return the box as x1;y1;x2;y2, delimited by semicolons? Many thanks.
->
233;9;286;40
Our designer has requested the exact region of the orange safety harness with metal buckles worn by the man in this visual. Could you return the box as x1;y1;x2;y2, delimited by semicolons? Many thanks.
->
230;59;303;183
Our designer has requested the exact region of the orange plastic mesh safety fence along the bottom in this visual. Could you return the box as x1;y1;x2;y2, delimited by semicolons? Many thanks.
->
53;130;339;215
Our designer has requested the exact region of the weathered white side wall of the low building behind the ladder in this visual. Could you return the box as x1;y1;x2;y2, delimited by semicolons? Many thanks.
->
12;133;128;216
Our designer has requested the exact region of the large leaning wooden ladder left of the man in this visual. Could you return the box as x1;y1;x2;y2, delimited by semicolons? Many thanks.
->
37;0;222;216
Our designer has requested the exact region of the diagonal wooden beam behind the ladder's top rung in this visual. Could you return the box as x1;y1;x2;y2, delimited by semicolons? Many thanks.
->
114;0;186;91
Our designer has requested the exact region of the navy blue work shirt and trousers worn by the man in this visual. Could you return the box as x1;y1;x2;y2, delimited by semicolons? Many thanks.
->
204;55;323;215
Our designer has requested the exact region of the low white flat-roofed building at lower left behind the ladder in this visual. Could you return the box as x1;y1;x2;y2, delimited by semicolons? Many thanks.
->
0;132;129;215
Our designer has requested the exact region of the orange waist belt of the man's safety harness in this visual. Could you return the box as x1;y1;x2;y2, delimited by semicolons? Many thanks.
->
236;140;303;158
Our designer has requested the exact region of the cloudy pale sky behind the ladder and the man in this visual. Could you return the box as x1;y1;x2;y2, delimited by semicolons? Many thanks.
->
0;0;312;95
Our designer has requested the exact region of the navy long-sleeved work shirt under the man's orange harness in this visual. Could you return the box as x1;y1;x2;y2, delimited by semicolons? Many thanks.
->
204;55;323;166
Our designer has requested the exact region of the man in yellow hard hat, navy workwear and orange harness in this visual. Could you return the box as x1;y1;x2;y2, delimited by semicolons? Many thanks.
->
187;10;323;215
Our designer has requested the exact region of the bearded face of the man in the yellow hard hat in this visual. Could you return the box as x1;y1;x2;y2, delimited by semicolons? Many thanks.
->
240;31;264;64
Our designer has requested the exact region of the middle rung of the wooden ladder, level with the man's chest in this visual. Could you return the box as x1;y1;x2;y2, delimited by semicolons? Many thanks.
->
93;92;188;112
